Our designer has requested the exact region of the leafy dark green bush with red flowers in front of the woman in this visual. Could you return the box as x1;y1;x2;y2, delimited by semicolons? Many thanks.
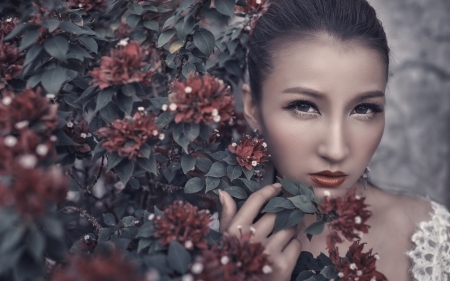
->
0;0;385;281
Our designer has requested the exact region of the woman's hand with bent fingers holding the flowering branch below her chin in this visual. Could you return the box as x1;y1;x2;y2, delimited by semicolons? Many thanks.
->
219;183;302;281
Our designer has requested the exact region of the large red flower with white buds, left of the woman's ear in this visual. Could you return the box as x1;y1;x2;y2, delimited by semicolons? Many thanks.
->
168;74;234;124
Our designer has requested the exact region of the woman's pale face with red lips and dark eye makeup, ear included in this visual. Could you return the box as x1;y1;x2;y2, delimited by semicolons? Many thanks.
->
244;35;387;196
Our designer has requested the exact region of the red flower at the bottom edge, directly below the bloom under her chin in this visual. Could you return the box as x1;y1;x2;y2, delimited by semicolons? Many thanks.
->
330;241;387;281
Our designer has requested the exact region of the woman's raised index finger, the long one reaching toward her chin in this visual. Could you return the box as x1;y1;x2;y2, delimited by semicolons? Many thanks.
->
231;183;281;225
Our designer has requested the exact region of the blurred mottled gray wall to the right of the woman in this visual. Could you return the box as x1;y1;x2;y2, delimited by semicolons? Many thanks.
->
369;0;450;207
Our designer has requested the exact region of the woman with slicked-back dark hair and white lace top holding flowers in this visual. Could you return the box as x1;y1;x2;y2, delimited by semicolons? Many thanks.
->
216;0;450;280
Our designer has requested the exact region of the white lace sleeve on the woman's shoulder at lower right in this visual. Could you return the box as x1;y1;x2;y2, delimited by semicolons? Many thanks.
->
407;202;450;281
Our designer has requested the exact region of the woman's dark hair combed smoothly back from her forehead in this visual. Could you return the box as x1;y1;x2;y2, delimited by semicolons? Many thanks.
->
248;0;389;102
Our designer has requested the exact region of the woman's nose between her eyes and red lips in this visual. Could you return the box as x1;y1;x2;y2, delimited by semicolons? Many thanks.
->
317;122;350;163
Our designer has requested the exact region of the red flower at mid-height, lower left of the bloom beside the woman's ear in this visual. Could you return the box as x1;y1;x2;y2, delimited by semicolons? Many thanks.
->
97;112;159;159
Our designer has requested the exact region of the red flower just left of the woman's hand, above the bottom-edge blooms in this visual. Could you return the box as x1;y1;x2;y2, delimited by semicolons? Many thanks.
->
155;201;211;250
